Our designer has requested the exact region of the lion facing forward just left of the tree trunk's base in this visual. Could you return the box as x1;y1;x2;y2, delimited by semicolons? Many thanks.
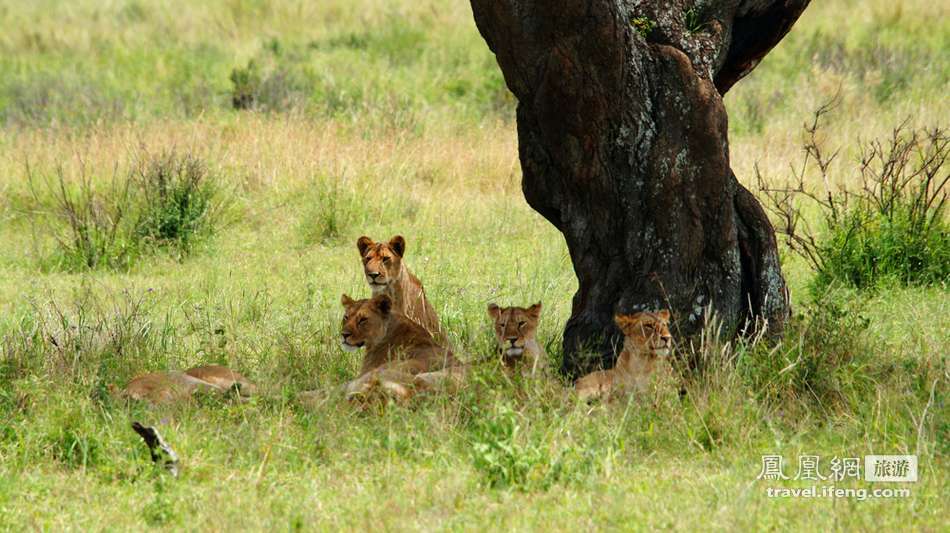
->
488;302;548;376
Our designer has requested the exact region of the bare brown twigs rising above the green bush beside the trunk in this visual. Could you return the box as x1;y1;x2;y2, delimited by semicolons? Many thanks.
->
755;96;950;284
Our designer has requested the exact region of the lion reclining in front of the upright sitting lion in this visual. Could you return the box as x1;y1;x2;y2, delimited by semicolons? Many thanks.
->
340;294;458;398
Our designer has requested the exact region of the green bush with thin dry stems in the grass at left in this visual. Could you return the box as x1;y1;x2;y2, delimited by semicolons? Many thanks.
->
27;152;223;272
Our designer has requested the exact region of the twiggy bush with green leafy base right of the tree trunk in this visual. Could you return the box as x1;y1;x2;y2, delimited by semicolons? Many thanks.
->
757;103;950;291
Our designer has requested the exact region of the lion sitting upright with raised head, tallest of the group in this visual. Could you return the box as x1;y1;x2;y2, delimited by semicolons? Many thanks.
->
356;235;444;338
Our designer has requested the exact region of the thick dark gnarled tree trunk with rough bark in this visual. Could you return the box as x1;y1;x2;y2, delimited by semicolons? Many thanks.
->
471;0;809;376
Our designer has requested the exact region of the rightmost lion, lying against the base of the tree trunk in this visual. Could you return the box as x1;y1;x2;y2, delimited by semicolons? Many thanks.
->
575;310;672;400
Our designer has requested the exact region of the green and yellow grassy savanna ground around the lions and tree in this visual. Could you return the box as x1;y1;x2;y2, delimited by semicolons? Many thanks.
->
0;0;950;530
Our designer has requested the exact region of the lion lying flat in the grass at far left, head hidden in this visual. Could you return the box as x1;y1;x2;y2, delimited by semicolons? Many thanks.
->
111;365;255;404
